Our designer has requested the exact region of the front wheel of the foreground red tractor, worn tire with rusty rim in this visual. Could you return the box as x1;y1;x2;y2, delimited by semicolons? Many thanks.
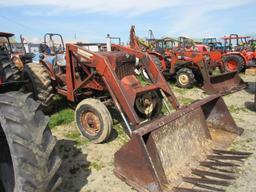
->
75;99;113;143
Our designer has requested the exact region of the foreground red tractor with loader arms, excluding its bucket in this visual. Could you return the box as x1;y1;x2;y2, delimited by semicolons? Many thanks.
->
23;40;178;143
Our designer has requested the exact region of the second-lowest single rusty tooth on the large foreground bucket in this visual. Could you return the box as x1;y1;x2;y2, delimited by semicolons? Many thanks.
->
183;177;230;186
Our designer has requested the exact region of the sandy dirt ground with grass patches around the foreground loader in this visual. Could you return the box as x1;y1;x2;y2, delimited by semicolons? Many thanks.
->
53;75;256;192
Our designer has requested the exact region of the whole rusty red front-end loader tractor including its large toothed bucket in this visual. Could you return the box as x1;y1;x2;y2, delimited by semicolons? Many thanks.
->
23;39;249;192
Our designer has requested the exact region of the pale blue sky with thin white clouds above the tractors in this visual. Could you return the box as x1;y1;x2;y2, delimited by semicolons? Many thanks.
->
0;0;256;42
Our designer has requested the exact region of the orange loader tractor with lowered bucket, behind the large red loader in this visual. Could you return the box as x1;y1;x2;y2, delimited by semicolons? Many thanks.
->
130;26;246;94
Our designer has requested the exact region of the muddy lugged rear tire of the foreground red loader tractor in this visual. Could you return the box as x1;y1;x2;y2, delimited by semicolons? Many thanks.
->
22;63;54;109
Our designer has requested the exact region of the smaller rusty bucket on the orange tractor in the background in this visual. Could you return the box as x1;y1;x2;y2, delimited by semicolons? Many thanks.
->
202;71;247;95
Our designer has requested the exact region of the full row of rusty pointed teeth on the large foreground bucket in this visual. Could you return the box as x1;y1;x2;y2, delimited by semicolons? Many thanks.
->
174;150;251;192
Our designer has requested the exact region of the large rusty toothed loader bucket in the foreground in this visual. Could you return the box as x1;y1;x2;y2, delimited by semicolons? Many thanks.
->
114;95;249;192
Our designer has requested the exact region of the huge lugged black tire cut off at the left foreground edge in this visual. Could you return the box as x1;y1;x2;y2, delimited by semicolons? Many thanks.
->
0;92;61;192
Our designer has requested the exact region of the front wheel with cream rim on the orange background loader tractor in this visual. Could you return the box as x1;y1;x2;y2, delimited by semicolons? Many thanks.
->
176;67;196;89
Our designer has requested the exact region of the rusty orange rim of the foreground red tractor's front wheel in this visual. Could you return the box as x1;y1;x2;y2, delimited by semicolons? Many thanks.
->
80;111;101;136
